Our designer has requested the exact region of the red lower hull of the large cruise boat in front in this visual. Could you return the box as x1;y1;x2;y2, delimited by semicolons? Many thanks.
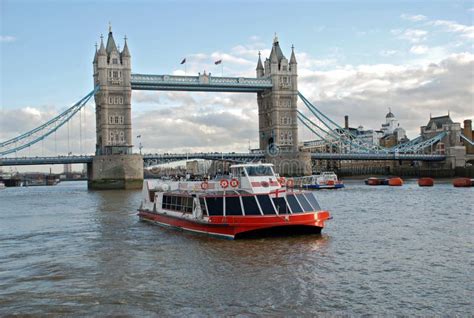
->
138;210;330;239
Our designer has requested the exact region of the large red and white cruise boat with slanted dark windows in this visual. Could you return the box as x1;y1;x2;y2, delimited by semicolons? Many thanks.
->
138;163;331;239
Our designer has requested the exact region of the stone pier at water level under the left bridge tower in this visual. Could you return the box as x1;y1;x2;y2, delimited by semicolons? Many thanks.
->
87;155;143;190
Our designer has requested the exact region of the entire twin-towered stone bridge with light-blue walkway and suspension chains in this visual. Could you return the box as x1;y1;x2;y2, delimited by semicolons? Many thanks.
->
0;28;462;189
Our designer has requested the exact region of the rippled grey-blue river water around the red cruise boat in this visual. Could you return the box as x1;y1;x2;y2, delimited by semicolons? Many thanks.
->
0;181;474;316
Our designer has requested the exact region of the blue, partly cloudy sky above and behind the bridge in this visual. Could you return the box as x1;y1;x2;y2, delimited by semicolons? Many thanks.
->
0;0;474;173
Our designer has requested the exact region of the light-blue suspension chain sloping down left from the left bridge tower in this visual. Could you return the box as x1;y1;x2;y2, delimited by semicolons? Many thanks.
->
0;86;99;156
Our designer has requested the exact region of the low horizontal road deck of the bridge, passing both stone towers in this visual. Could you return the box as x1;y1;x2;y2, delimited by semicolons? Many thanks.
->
0;152;446;166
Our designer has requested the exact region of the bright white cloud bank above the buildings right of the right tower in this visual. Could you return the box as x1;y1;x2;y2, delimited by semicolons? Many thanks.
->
299;53;474;137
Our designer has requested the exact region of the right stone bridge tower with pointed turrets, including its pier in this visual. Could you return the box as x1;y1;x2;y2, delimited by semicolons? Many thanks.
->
256;35;311;175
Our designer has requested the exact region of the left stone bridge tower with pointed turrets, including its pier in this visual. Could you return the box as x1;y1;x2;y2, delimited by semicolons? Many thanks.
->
88;26;143;189
